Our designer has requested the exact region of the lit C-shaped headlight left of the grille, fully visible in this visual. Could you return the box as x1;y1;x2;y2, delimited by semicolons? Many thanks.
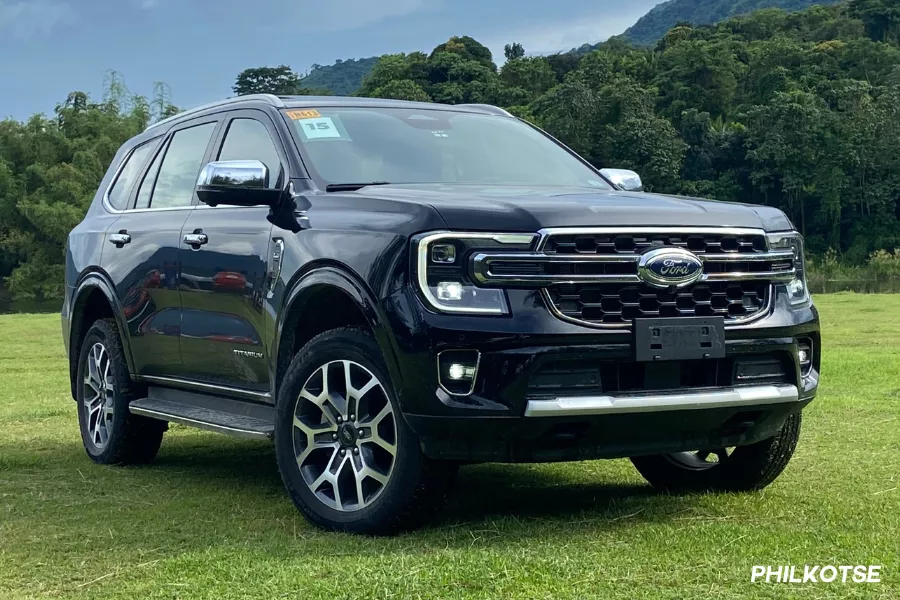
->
412;233;538;315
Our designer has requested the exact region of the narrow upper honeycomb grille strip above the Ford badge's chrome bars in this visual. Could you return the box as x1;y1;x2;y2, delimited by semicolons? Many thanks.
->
544;232;766;254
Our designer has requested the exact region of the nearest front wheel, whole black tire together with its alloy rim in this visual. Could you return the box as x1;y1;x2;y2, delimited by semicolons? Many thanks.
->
275;328;456;535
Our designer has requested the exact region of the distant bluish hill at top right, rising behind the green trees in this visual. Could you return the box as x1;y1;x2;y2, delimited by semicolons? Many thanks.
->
622;0;841;46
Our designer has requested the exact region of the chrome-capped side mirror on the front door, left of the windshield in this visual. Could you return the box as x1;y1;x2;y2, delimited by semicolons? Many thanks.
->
197;160;281;206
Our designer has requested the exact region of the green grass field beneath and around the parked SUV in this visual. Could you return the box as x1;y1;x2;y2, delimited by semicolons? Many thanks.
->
0;294;900;600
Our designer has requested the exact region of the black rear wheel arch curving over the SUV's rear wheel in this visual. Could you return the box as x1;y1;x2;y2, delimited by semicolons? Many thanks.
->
68;272;134;398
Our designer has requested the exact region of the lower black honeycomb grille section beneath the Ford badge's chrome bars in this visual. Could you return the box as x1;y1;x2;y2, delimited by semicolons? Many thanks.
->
547;280;772;325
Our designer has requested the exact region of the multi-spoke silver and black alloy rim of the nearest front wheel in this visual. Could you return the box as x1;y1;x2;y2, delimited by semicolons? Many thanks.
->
292;360;397;512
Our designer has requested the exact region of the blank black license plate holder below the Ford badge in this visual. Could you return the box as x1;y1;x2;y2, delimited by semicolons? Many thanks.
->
634;317;725;362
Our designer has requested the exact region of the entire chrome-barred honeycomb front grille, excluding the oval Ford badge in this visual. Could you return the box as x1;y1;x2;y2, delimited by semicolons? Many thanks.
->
470;227;796;328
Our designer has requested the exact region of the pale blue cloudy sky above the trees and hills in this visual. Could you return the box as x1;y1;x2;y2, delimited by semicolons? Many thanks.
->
0;0;660;120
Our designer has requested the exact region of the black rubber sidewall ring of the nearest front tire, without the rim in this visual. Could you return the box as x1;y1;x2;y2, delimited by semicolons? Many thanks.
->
275;329;422;530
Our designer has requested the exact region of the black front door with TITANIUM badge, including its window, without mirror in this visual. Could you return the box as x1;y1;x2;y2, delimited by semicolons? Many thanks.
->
180;110;286;395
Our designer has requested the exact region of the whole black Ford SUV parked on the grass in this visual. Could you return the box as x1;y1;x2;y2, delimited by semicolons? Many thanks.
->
62;95;821;533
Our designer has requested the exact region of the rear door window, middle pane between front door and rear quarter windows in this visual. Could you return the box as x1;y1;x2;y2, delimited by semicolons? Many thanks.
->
148;123;216;208
